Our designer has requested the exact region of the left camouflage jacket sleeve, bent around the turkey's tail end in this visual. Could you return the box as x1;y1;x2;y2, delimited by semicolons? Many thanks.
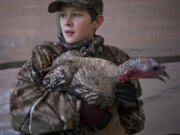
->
10;43;80;134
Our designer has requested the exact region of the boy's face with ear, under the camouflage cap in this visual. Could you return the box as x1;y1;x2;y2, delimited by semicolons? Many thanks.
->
60;4;98;44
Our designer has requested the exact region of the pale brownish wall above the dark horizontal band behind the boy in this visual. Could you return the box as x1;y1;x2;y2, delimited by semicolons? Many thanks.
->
0;0;180;63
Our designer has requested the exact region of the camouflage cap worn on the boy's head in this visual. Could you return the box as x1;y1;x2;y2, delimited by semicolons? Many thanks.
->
48;0;103;14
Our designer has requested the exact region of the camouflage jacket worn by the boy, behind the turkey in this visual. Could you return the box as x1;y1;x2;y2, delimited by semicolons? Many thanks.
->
10;36;145;135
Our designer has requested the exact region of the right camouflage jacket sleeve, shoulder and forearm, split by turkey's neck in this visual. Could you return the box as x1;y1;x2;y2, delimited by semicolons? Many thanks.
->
102;46;145;134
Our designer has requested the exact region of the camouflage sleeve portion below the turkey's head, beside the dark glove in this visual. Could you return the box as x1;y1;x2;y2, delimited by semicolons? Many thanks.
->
118;80;145;134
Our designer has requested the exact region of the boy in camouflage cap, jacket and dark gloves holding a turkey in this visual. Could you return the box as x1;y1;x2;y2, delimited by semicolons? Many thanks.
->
10;0;144;135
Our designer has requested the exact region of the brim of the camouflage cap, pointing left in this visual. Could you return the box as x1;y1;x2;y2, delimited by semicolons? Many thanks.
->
48;1;64;13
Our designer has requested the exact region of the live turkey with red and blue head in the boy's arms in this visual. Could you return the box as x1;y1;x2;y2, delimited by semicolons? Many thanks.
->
42;50;168;108
